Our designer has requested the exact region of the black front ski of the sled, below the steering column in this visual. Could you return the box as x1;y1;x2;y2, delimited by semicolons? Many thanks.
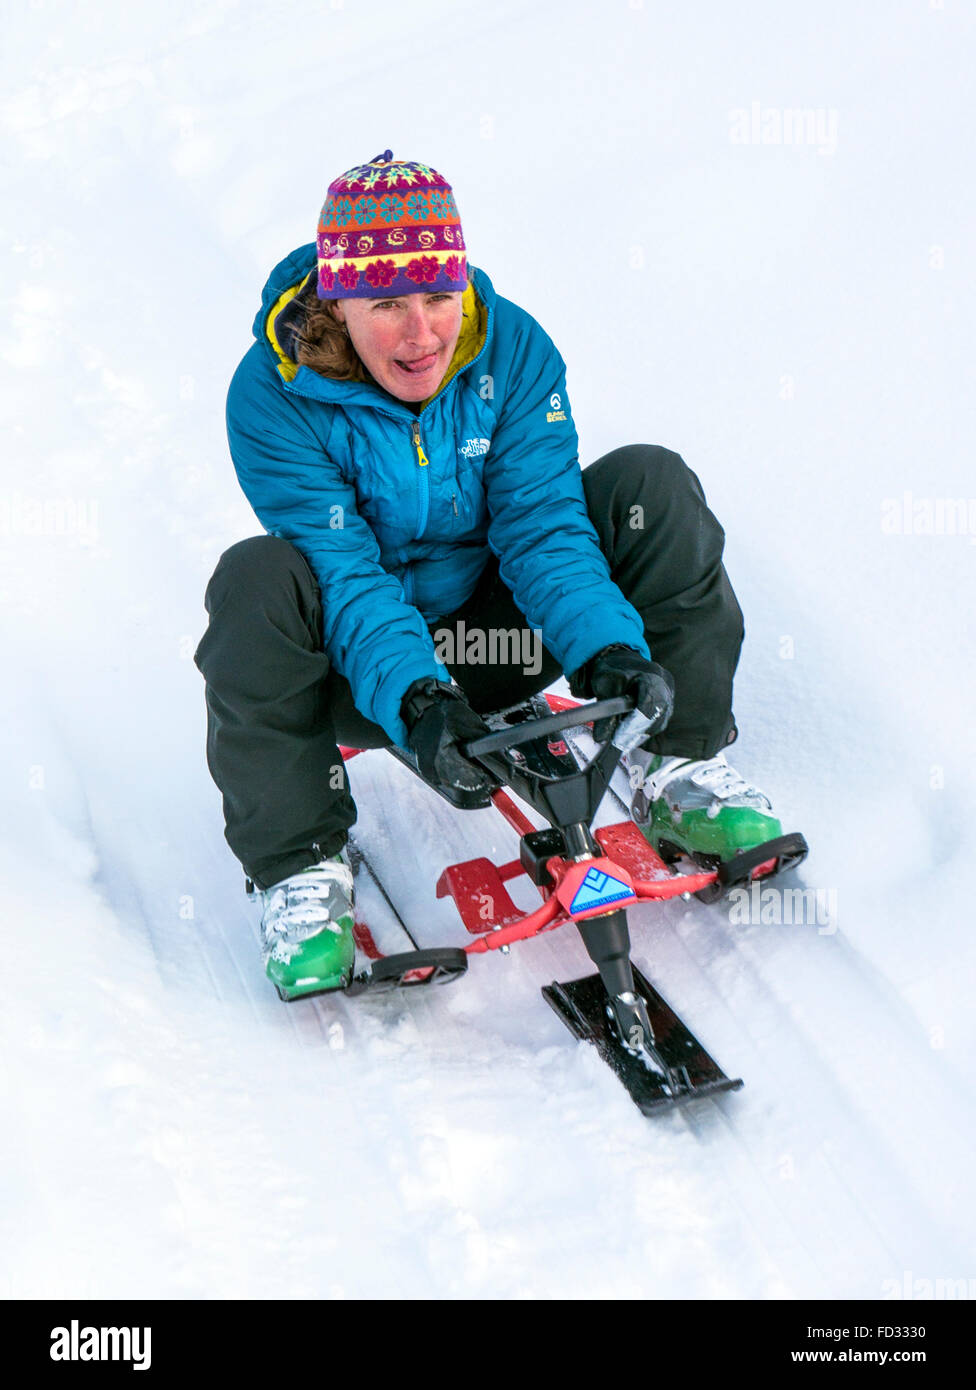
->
542;966;742;1115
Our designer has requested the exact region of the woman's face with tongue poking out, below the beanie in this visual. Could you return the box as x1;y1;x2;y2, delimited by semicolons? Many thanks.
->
335;291;462;400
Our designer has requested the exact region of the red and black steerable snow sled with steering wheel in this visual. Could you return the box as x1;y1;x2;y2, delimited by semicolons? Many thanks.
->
342;695;808;1113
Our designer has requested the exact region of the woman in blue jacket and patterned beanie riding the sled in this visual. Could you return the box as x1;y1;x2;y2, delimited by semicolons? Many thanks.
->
196;150;780;997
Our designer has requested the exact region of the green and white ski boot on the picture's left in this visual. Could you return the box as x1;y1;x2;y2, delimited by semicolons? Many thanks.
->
255;851;356;999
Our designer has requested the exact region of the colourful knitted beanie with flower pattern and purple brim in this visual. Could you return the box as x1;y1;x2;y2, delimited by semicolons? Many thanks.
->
317;150;467;299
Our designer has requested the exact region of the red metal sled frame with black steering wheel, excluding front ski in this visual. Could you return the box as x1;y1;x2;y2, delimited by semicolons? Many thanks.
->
341;695;805;984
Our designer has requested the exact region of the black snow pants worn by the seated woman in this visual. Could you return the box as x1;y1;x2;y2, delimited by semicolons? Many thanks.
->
195;443;742;888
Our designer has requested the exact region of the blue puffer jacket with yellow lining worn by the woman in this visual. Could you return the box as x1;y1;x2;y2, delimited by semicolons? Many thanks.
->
227;243;648;746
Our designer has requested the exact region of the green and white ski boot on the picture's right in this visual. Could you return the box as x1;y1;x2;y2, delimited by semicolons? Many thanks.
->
630;749;783;866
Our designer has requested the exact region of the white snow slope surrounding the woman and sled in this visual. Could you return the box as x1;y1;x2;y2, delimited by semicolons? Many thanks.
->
0;0;976;1300
